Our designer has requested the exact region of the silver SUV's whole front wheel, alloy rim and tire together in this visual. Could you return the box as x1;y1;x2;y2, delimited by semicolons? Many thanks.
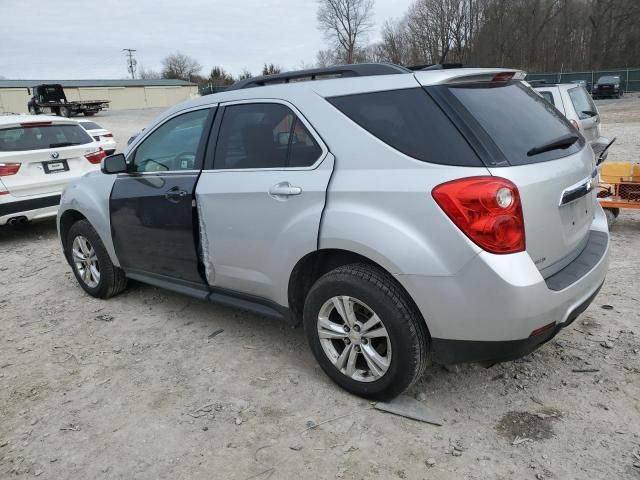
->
66;220;127;298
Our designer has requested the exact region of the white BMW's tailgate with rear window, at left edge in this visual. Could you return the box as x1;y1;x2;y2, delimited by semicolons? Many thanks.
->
0;121;99;197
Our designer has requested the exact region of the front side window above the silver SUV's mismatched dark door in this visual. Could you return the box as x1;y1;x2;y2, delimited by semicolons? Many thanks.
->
132;109;209;172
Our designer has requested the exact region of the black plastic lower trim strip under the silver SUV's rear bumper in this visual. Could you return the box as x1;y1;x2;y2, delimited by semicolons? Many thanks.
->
431;284;602;365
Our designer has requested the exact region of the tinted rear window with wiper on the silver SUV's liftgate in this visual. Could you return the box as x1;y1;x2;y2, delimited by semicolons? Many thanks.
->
444;82;584;165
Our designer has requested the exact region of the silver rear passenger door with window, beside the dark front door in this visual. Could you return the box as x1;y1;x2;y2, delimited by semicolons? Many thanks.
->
196;100;333;304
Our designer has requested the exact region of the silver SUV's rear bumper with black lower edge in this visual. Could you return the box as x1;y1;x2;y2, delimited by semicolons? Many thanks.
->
396;208;609;363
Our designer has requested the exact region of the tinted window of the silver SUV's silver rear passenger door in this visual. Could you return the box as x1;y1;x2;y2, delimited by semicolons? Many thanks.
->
214;103;322;169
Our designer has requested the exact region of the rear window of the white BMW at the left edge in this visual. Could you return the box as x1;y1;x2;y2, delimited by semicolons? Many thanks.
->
0;125;93;152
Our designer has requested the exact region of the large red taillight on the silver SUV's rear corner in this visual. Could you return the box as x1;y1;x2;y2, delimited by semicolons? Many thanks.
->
432;177;525;254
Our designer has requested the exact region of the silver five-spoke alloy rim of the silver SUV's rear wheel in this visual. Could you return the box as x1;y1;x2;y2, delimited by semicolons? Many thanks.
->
318;296;391;382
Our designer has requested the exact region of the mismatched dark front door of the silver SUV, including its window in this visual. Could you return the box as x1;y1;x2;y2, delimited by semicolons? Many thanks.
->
109;108;214;286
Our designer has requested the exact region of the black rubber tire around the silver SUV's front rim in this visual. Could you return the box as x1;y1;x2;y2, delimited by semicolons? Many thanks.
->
66;220;127;299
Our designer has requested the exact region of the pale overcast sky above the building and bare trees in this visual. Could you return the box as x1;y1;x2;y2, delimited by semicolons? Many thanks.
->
0;0;413;80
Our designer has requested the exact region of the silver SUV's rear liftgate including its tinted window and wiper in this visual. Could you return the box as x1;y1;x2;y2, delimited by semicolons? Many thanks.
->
427;82;596;277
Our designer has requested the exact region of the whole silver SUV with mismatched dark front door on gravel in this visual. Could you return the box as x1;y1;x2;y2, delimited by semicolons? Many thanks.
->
58;64;609;399
